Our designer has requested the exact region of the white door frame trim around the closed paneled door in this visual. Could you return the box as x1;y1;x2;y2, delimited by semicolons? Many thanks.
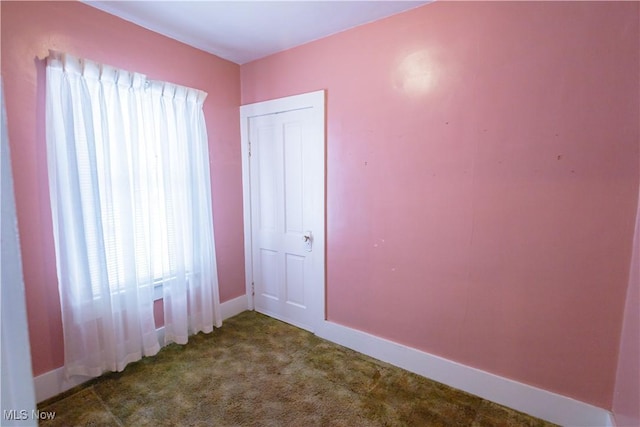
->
240;90;326;331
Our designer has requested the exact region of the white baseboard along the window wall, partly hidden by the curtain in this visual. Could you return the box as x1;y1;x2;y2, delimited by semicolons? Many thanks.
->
33;295;248;403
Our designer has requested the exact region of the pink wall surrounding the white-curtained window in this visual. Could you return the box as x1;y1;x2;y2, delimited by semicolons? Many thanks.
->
0;1;245;375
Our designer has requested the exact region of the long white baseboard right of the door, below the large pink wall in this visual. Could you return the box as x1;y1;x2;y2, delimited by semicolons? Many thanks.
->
316;322;615;427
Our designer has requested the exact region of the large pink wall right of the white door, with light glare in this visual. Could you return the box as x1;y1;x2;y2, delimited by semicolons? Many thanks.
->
241;2;640;408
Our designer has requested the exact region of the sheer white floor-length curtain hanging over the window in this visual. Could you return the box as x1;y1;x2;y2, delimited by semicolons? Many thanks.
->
46;52;221;376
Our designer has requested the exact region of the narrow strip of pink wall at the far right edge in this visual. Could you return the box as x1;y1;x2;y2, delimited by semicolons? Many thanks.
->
613;192;640;427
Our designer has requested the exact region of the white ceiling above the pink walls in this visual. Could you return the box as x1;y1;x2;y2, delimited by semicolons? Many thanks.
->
84;0;431;64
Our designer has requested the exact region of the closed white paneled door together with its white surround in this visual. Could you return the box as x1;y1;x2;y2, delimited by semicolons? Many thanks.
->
241;92;325;331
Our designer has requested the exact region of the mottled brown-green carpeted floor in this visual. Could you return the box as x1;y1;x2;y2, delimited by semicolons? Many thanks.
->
38;311;552;427
